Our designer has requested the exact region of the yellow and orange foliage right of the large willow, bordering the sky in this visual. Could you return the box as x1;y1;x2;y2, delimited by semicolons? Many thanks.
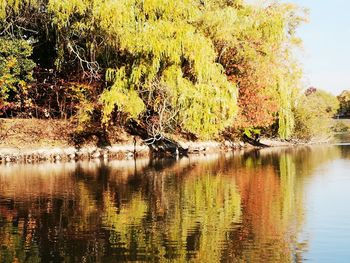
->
197;1;305;139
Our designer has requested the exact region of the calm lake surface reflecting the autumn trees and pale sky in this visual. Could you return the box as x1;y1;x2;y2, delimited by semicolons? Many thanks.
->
0;144;350;262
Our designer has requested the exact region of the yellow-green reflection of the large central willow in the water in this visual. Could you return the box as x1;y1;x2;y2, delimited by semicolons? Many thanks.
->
103;168;241;262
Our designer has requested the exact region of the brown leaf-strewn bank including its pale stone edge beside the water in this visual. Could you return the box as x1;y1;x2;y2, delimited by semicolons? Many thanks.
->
0;119;306;163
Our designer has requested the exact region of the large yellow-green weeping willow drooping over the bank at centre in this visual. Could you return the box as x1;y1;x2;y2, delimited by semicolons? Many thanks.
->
45;0;237;137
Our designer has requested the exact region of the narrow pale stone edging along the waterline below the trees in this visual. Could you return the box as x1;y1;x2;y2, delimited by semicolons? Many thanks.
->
0;139;300;164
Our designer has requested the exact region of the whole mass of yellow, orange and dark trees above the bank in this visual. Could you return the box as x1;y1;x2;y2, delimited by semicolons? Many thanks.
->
0;0;318;142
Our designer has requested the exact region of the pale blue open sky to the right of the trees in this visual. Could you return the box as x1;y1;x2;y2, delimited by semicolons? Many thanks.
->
246;0;350;95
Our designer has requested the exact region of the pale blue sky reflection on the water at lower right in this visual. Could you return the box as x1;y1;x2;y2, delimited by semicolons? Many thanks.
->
303;160;350;263
